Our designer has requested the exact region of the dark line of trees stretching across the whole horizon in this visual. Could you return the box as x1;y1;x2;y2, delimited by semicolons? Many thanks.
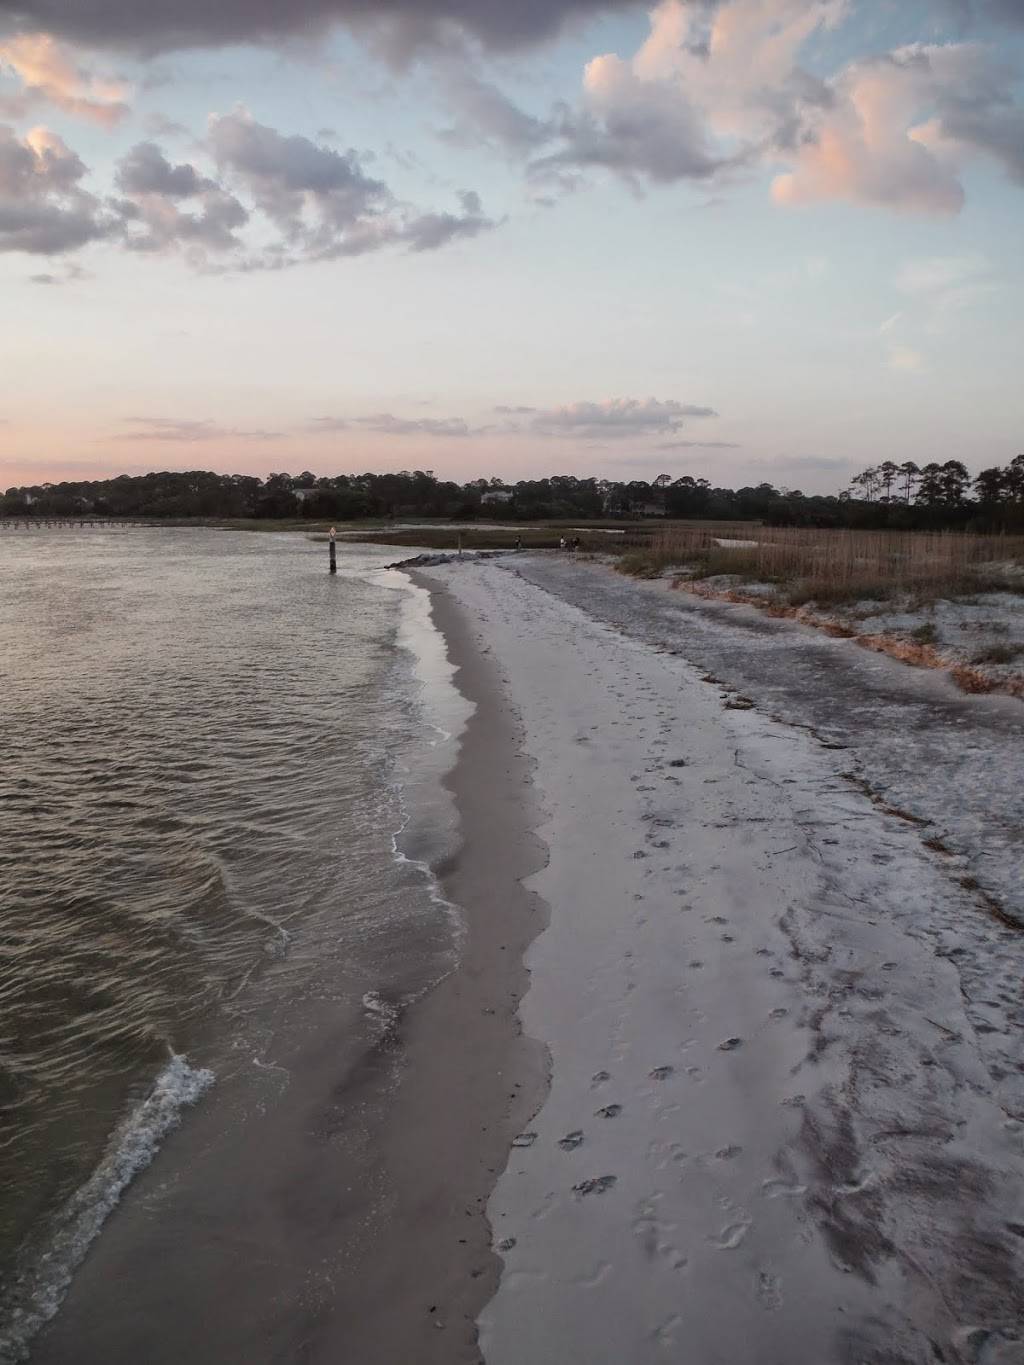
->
0;455;1024;531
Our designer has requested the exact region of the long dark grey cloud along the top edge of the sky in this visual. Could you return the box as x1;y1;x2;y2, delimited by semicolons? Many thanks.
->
2;0;636;56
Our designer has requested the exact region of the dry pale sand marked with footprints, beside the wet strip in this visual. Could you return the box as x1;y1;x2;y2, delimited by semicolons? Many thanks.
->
430;562;1024;1365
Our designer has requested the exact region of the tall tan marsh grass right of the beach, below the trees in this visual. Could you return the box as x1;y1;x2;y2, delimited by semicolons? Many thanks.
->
633;527;1024;603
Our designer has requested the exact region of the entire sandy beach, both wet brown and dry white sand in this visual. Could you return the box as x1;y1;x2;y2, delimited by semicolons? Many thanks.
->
31;556;1024;1365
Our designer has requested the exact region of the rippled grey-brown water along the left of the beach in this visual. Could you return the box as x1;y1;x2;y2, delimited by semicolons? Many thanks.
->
0;530;466;1360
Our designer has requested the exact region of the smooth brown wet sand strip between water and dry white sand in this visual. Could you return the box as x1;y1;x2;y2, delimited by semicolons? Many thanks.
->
31;570;546;1365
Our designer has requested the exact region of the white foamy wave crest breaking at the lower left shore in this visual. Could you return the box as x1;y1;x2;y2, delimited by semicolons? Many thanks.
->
0;1054;214;1362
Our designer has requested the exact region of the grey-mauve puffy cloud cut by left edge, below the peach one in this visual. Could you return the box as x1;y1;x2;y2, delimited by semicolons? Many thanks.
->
0;124;113;255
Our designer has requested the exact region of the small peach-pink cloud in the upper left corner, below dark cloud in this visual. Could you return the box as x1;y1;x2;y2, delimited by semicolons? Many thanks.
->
0;33;128;128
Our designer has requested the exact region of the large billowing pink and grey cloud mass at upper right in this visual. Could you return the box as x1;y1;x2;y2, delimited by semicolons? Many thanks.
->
491;0;1024;214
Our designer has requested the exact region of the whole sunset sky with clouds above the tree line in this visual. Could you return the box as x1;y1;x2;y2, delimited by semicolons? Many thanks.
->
0;0;1024;493
